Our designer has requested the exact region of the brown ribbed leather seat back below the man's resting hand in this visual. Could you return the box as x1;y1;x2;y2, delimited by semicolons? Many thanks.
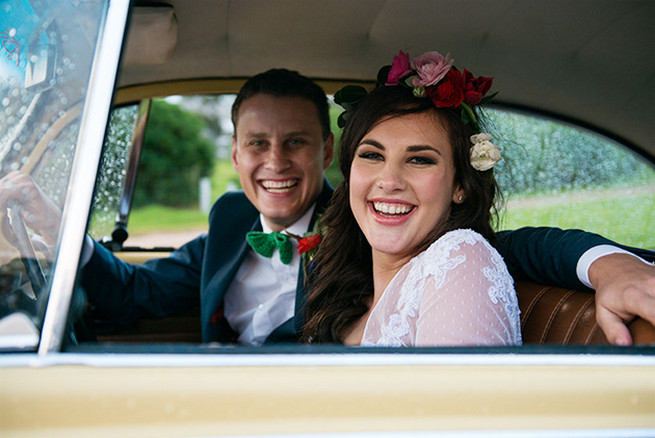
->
515;281;655;345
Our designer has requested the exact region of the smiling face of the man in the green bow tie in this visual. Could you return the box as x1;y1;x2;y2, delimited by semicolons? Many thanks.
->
231;94;334;231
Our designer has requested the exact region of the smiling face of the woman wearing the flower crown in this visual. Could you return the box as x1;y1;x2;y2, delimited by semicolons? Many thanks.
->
350;113;463;261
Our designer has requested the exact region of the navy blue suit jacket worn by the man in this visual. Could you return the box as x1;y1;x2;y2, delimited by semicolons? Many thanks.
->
80;182;652;342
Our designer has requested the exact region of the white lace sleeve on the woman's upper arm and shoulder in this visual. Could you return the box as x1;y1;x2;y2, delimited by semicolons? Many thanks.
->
415;230;521;346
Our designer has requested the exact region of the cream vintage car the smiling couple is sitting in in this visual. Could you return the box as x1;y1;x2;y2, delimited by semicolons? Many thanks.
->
0;0;655;437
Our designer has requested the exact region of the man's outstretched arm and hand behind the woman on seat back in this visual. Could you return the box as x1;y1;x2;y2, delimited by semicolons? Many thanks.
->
497;227;655;345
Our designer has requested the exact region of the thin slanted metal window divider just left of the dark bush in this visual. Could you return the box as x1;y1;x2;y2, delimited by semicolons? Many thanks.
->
116;99;151;226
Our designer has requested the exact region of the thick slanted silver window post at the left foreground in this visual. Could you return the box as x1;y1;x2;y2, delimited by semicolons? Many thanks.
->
38;0;130;356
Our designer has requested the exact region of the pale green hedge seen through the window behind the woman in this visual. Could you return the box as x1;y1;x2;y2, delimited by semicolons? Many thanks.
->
488;111;653;195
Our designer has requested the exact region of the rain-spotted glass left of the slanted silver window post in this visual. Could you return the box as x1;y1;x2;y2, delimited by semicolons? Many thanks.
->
0;0;107;347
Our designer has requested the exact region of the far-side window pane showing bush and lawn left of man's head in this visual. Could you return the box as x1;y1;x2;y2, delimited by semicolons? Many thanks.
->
120;95;240;249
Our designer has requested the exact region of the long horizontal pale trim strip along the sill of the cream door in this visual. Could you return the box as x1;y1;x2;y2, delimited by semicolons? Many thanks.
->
7;351;655;373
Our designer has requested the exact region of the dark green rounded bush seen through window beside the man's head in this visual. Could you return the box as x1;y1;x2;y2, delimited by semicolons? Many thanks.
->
132;100;214;207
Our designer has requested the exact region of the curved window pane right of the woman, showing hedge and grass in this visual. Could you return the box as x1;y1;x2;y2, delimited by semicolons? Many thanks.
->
489;110;655;248
